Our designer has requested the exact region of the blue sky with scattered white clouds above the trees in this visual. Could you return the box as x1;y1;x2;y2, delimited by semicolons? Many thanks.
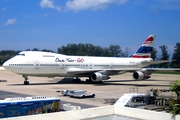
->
0;0;180;53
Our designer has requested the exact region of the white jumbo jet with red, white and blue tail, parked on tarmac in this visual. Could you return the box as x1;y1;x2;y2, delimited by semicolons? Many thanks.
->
3;34;179;85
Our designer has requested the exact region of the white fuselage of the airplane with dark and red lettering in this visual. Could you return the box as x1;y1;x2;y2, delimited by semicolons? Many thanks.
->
3;51;152;77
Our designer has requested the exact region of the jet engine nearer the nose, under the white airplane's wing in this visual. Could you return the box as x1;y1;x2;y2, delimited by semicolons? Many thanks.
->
91;72;109;82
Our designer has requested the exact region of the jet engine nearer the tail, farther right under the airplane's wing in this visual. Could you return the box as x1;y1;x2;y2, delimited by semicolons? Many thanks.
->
133;71;151;80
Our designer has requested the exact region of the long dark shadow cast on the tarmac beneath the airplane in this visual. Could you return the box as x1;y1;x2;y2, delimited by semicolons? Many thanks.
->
8;78;169;87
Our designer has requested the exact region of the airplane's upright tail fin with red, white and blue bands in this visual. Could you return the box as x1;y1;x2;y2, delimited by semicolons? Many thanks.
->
132;34;156;58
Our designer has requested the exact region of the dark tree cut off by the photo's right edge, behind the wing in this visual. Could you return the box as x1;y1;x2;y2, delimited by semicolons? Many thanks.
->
171;42;180;68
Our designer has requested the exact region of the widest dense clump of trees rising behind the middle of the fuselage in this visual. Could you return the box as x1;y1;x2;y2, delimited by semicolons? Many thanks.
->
58;43;125;57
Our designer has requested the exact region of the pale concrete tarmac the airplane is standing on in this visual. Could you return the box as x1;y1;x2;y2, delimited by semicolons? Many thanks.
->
0;70;180;106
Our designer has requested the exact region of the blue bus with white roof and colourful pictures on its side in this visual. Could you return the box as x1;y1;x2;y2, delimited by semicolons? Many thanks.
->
0;96;60;118
